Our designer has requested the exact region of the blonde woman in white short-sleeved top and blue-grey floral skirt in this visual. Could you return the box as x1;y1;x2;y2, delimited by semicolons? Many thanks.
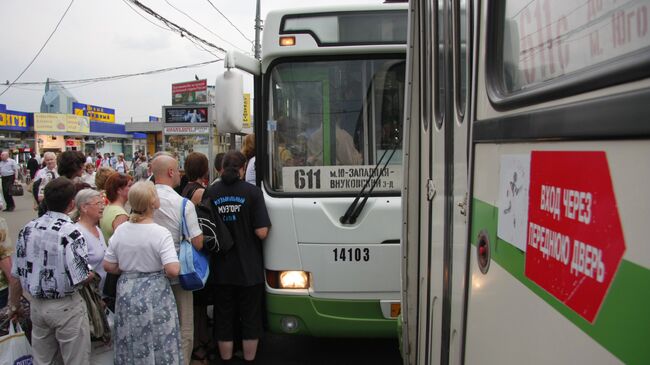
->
104;181;183;364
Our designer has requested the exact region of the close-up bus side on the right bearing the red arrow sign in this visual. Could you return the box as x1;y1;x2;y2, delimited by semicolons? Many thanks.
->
401;0;650;364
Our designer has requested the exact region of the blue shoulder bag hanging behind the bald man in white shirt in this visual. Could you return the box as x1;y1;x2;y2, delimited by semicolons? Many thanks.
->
178;198;210;291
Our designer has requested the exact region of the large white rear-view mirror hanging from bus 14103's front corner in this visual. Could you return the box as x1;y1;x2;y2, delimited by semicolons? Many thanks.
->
214;70;244;133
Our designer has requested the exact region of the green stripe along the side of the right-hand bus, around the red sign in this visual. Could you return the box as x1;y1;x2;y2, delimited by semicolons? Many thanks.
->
471;199;650;364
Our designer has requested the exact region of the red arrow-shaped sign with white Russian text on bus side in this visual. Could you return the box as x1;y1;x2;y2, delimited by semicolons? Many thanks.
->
525;151;625;323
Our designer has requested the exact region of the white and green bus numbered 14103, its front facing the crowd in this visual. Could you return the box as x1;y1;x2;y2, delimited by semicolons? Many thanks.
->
217;4;408;337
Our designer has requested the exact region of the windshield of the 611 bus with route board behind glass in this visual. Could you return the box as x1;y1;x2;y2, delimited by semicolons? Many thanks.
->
267;57;405;193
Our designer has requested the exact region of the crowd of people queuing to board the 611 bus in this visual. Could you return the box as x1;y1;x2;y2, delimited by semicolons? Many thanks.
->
0;140;271;364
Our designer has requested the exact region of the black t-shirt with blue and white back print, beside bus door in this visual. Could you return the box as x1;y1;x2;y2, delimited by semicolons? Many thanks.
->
204;180;271;286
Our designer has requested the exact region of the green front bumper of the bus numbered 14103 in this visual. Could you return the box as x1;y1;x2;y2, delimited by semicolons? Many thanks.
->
266;293;397;338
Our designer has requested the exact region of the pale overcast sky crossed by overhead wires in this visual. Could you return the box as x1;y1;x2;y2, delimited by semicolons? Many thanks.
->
0;0;382;123
